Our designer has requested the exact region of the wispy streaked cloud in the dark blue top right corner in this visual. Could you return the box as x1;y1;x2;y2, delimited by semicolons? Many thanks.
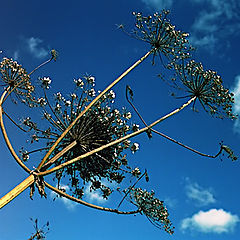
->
190;0;240;49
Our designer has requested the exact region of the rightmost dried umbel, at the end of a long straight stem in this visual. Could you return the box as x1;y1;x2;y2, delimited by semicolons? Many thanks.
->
175;60;236;119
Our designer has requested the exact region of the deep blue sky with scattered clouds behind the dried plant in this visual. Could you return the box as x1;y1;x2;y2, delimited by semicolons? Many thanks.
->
0;0;240;240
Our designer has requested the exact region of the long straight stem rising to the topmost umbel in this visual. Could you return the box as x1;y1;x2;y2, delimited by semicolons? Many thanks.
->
37;50;153;170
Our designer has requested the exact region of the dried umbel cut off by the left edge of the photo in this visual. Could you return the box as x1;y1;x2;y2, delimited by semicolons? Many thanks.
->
0;58;35;106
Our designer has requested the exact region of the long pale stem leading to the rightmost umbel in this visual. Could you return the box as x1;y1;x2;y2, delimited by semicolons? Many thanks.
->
39;97;196;176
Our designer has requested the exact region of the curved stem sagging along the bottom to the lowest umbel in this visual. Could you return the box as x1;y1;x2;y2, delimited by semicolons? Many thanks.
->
44;182;140;214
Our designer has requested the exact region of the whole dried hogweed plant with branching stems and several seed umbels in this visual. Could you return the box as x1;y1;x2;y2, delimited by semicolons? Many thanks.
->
0;11;236;234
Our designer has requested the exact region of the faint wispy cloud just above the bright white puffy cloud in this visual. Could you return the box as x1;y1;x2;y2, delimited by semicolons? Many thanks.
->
186;179;216;206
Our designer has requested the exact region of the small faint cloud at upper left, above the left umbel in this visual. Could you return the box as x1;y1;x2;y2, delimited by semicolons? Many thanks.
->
26;37;48;58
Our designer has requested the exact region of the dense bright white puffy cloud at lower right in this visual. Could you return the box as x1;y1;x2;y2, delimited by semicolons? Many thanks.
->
181;209;239;234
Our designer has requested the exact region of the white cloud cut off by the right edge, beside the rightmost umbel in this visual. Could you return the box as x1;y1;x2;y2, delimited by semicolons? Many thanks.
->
232;75;240;133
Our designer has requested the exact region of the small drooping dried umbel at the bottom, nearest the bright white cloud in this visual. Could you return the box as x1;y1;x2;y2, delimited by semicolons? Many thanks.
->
130;188;174;234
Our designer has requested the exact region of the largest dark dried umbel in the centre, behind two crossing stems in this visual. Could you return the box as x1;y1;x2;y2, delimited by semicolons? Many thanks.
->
21;76;140;198
